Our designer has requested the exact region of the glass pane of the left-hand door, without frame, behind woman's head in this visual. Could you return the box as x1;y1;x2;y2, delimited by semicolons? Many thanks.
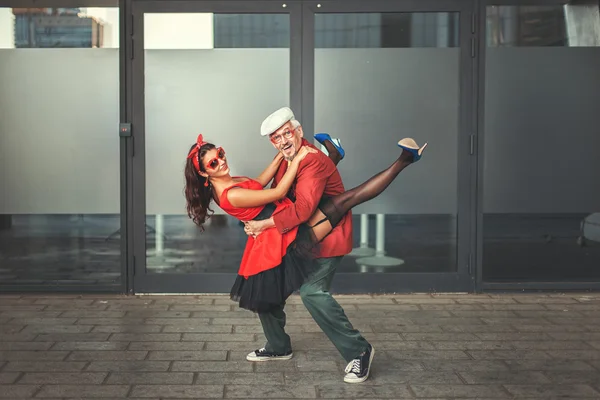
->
144;13;290;273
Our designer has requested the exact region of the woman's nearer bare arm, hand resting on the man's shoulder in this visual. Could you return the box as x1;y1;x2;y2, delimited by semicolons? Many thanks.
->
227;146;317;207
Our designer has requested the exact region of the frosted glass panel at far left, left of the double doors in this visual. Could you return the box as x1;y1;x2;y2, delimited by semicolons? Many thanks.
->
0;7;121;290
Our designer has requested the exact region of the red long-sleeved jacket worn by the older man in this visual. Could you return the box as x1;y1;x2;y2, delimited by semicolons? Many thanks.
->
271;139;352;257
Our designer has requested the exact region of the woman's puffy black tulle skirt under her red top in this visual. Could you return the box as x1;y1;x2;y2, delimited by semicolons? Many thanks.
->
230;205;315;313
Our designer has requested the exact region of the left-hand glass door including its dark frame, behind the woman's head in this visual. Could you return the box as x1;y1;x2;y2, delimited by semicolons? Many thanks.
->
132;1;301;293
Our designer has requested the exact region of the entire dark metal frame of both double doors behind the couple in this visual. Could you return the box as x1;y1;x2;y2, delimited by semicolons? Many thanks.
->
127;0;477;293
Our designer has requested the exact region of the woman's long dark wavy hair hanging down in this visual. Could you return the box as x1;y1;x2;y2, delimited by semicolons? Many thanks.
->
185;143;215;230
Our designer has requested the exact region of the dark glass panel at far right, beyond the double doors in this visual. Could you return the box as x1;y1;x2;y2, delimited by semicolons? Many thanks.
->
483;3;600;282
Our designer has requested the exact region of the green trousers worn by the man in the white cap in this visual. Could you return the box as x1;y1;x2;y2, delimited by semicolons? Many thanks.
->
258;257;369;362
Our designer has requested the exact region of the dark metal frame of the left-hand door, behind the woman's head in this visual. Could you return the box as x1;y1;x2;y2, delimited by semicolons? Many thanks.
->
127;0;301;293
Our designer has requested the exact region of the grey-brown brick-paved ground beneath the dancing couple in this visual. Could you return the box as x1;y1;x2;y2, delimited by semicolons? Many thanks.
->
0;293;600;400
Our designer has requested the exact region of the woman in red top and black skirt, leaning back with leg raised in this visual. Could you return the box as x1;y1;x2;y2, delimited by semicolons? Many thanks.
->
185;135;427;312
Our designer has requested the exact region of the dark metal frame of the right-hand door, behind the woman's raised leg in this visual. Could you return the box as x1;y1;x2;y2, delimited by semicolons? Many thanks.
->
301;0;477;293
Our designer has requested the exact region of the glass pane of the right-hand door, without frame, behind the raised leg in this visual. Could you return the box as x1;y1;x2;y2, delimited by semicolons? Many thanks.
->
315;13;460;273
